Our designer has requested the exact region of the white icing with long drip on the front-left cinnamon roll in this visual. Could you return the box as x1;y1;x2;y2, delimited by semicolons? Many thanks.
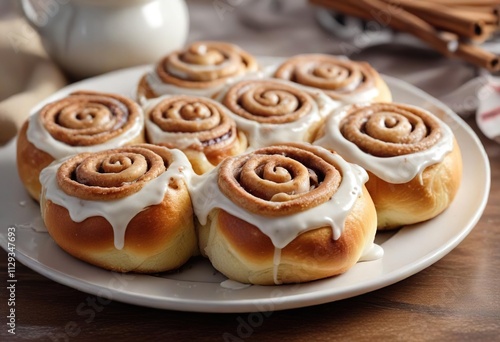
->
40;149;193;249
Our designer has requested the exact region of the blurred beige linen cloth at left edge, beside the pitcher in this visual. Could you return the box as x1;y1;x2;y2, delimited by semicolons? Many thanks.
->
0;12;66;145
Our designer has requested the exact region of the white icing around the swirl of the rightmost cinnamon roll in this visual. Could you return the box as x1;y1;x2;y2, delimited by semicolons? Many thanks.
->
314;105;453;184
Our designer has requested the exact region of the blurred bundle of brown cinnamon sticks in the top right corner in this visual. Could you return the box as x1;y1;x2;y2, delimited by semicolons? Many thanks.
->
309;0;500;71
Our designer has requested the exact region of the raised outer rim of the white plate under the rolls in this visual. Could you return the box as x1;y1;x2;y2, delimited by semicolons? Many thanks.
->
0;65;491;313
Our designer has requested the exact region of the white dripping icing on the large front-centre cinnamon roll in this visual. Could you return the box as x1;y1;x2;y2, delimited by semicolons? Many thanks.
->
191;150;368;248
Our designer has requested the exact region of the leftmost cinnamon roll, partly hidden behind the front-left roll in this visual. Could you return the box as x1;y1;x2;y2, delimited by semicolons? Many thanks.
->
17;91;144;200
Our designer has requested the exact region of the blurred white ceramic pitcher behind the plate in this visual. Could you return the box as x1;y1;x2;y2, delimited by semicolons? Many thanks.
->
21;0;189;79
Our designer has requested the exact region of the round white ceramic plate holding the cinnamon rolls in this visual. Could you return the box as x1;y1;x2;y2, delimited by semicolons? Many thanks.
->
0;62;490;312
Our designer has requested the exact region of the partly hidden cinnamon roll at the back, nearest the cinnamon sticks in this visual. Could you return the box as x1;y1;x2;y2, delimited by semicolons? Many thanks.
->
274;54;392;103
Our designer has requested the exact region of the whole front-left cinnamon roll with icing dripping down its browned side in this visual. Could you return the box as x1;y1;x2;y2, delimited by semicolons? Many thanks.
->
40;144;197;273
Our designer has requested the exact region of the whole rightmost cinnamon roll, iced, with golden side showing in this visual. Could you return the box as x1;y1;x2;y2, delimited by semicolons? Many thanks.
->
315;103;462;229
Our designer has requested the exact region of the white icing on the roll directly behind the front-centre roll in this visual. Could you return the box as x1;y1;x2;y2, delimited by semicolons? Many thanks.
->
217;78;340;149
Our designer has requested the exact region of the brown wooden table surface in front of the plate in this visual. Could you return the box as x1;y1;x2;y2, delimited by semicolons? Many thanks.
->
0;119;500;341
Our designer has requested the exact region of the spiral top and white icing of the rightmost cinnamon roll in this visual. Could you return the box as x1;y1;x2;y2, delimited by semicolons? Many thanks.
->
314;103;453;184
